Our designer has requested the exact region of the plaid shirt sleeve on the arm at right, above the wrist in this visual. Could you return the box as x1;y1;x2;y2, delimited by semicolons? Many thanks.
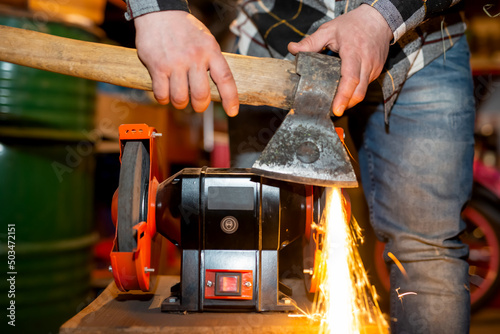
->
363;0;461;42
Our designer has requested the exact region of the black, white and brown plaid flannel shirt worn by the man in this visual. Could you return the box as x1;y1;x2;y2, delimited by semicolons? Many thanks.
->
126;0;465;118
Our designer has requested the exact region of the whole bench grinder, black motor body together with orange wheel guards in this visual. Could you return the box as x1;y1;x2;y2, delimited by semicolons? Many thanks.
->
111;124;350;311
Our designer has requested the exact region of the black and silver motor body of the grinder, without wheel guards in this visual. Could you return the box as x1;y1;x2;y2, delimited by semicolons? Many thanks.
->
156;167;326;311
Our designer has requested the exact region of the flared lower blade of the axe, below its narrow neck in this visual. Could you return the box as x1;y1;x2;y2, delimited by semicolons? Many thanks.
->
252;110;358;188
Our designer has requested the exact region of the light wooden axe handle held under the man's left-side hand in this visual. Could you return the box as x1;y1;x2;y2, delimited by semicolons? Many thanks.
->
0;26;299;109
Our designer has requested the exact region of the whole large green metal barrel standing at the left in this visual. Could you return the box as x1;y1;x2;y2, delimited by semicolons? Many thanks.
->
0;14;96;333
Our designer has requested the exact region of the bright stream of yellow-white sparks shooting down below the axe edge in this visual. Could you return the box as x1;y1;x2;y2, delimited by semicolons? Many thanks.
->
310;188;388;334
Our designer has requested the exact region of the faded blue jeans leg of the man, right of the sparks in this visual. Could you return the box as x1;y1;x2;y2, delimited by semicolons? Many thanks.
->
350;37;475;334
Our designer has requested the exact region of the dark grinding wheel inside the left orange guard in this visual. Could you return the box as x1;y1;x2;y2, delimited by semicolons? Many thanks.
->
117;141;149;252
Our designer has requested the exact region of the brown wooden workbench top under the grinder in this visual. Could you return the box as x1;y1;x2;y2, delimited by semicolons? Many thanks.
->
59;276;318;334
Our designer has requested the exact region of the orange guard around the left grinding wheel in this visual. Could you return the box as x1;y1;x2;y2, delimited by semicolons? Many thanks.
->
110;124;162;291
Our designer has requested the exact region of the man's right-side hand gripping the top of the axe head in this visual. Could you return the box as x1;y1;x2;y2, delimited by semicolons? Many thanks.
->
288;5;393;116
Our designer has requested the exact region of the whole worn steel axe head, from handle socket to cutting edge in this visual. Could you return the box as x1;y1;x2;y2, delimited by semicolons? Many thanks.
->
252;52;358;188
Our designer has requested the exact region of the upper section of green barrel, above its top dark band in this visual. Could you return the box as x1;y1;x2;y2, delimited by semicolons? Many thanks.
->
0;16;95;136
